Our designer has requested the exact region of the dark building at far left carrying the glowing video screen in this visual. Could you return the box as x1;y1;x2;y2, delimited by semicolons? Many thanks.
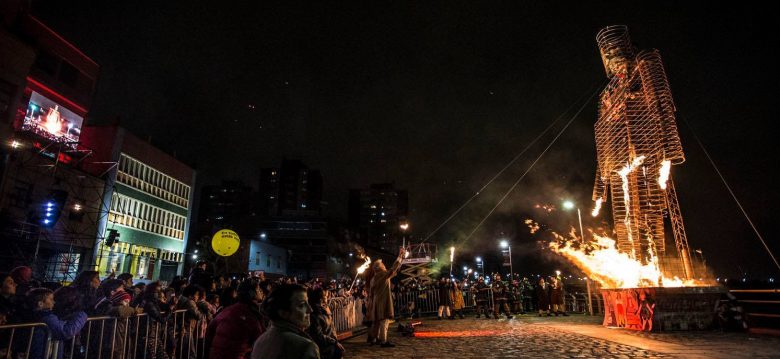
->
0;5;104;281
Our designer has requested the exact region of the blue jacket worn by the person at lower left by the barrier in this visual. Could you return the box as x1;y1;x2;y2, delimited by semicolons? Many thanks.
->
28;310;87;359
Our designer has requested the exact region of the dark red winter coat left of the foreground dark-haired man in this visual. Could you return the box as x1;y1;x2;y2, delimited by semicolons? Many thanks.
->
206;303;265;359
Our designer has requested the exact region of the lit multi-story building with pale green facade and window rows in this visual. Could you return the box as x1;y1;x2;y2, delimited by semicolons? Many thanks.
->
82;126;195;280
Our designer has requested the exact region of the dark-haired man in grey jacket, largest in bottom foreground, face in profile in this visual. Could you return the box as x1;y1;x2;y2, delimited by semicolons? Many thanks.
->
251;284;320;359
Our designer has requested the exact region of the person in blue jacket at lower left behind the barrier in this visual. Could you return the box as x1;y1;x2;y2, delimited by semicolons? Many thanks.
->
26;288;87;359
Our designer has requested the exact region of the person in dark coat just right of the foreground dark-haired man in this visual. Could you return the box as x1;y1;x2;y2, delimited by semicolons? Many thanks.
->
307;288;344;359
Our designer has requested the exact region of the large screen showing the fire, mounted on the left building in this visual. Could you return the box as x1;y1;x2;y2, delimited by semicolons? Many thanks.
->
22;91;84;142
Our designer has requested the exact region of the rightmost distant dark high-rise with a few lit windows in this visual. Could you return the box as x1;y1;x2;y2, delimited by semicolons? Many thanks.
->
349;183;409;251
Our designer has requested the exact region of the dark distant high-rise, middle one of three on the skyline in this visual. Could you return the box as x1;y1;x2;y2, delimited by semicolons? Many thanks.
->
259;160;322;216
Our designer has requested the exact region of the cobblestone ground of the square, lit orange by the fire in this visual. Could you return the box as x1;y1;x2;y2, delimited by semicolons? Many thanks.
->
344;315;780;359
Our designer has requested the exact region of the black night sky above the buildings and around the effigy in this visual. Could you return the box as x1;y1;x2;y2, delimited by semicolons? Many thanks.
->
33;1;780;276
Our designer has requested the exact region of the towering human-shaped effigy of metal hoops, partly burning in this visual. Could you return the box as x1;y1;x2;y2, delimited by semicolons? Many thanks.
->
593;25;694;279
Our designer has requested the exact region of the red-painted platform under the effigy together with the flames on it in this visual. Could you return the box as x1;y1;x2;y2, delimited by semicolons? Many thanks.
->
549;234;724;331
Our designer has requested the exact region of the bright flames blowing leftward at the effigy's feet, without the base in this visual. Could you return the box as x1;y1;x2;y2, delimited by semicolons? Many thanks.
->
549;233;711;288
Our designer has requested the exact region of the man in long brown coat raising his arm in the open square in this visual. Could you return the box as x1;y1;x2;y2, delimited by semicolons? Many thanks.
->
366;248;406;347
